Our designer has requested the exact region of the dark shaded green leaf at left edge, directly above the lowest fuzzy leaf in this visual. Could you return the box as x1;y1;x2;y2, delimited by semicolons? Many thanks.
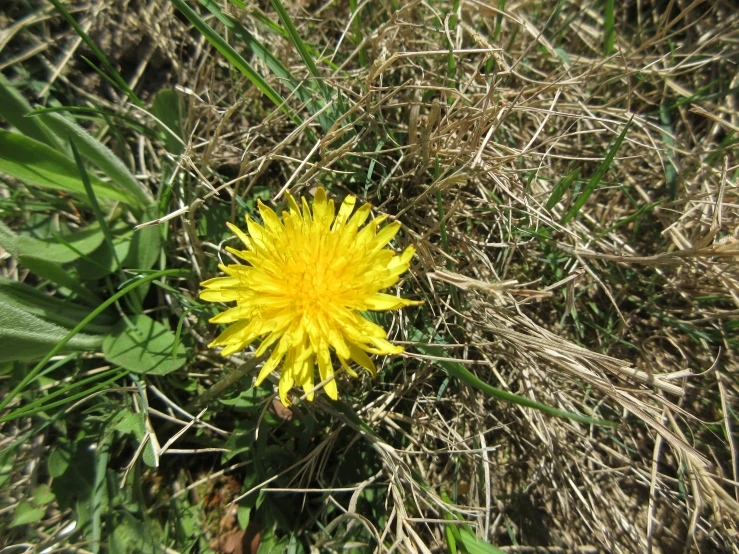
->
0;276;113;334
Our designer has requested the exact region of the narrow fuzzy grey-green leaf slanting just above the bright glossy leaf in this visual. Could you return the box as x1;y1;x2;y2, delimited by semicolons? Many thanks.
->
36;112;154;210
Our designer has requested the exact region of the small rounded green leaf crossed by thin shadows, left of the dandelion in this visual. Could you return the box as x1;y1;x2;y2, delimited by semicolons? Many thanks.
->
103;315;186;375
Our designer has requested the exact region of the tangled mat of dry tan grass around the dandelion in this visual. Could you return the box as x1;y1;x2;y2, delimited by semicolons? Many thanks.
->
2;0;739;553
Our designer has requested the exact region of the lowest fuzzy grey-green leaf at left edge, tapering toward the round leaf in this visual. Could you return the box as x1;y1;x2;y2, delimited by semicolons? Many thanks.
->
0;298;103;362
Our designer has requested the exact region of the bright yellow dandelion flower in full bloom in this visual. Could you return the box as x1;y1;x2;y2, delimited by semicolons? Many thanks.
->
200;188;422;406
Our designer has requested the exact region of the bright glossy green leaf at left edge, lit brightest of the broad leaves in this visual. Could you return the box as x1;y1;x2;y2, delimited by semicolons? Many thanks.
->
0;129;131;203
